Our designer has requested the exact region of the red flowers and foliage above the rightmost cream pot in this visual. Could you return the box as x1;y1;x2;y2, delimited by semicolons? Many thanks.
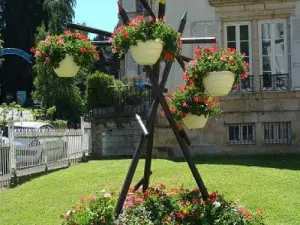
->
184;45;249;88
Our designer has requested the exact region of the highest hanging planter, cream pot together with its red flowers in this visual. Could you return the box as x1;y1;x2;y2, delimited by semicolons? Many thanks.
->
111;16;182;65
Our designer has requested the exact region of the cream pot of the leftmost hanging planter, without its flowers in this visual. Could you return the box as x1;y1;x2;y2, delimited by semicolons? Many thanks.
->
54;54;80;77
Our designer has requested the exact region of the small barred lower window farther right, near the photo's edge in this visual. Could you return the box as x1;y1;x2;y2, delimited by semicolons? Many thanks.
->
262;122;291;144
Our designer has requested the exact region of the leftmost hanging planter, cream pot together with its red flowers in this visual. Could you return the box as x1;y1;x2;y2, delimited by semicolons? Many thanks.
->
31;30;99;77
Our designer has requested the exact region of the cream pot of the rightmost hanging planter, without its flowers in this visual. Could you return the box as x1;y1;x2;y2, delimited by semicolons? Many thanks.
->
203;71;234;96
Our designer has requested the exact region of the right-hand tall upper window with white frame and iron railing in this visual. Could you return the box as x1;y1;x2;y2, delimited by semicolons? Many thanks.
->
259;20;289;90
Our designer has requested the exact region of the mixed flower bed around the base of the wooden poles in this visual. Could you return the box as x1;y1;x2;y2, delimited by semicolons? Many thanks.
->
61;184;264;225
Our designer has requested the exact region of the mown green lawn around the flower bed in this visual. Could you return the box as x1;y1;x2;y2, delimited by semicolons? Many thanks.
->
0;156;300;225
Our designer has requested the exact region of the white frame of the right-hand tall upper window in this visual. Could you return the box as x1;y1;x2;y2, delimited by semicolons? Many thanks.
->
258;19;289;75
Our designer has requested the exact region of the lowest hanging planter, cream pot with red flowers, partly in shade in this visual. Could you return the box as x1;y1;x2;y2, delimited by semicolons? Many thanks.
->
167;85;221;129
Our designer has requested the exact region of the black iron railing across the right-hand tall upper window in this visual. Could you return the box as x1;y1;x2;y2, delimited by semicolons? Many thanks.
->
260;73;290;91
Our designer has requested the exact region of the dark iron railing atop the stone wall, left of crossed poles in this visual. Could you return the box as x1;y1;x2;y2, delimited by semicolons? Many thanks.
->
92;85;151;118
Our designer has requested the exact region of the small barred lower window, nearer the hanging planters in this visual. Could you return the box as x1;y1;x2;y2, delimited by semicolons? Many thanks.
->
228;123;256;145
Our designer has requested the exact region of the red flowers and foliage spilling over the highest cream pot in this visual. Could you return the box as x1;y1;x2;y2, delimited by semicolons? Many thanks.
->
111;16;182;61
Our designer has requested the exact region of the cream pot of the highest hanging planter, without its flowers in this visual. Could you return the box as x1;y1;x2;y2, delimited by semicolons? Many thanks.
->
130;40;164;65
